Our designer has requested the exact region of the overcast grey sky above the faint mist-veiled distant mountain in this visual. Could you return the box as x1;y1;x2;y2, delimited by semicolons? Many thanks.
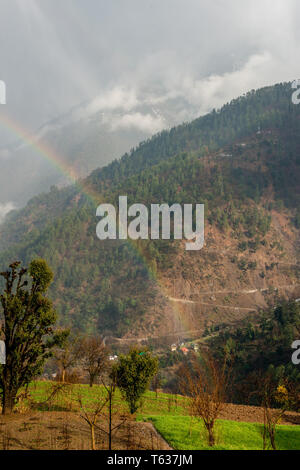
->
0;0;300;146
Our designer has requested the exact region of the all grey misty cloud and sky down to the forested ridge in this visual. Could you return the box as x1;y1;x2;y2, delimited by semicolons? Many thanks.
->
0;0;300;207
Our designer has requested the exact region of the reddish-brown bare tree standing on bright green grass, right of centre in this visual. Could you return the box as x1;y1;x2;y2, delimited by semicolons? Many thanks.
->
181;353;229;446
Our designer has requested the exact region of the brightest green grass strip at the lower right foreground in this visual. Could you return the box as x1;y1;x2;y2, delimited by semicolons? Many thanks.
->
148;415;300;450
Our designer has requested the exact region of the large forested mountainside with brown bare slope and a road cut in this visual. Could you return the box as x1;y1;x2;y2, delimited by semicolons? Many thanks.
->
0;84;300;337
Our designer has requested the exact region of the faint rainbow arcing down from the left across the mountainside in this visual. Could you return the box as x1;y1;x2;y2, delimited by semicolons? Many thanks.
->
0;110;197;335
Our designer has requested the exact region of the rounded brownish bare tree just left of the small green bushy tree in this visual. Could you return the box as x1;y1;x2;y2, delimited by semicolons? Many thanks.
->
79;336;108;387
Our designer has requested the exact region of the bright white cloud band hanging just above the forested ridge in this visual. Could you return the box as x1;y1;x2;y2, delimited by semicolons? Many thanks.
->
49;51;288;137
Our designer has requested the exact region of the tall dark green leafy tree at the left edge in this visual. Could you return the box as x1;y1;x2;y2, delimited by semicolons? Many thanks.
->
0;259;64;414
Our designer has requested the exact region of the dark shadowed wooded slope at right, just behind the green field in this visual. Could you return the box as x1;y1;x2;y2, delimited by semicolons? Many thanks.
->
208;301;300;410
